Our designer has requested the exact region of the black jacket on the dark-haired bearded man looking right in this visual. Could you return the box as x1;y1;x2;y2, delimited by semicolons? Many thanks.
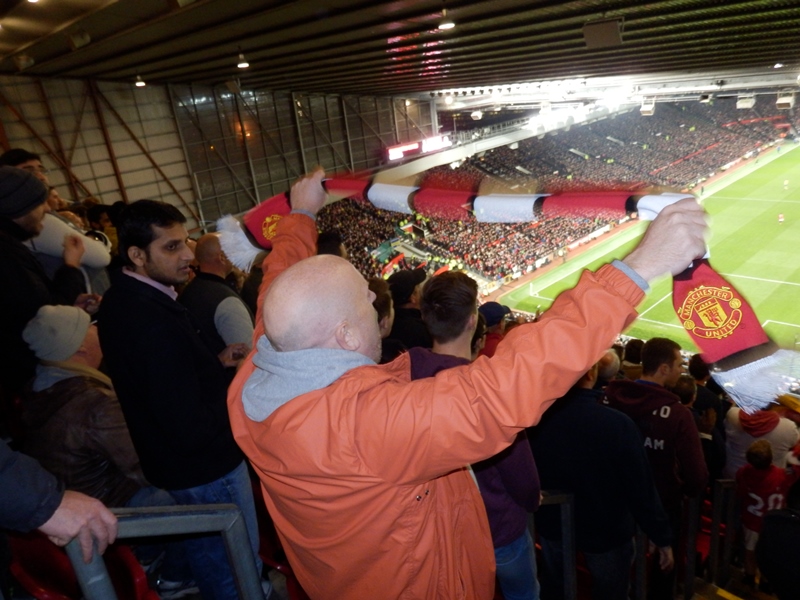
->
98;273;243;490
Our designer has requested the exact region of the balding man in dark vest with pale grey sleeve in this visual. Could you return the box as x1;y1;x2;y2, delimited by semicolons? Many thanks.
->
178;233;253;354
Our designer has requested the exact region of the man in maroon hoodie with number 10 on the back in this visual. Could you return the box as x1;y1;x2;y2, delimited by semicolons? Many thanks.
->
604;338;708;598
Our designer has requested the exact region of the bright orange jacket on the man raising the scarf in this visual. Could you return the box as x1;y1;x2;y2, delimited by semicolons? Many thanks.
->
228;213;643;600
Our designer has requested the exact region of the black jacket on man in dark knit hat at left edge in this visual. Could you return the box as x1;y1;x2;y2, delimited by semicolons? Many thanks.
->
0;219;86;394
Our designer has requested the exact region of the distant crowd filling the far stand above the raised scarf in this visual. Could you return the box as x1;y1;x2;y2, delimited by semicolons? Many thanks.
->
444;97;795;192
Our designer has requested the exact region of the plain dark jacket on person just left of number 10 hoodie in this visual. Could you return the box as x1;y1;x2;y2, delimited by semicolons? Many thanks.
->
528;389;672;552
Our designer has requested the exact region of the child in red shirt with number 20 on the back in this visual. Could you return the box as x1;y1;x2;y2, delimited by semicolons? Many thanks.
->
736;440;800;591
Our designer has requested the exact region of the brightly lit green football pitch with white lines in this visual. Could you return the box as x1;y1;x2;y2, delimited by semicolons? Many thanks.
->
499;144;800;352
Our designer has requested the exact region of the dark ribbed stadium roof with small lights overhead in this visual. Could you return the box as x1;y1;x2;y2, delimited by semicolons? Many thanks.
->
0;0;800;105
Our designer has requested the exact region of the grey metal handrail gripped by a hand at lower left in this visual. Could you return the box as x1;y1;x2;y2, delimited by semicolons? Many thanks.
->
66;504;264;600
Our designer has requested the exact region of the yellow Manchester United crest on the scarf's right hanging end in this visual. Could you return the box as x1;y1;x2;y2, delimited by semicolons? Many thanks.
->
678;285;742;339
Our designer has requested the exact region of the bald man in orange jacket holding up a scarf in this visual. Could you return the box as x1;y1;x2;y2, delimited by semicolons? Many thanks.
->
228;171;706;600
